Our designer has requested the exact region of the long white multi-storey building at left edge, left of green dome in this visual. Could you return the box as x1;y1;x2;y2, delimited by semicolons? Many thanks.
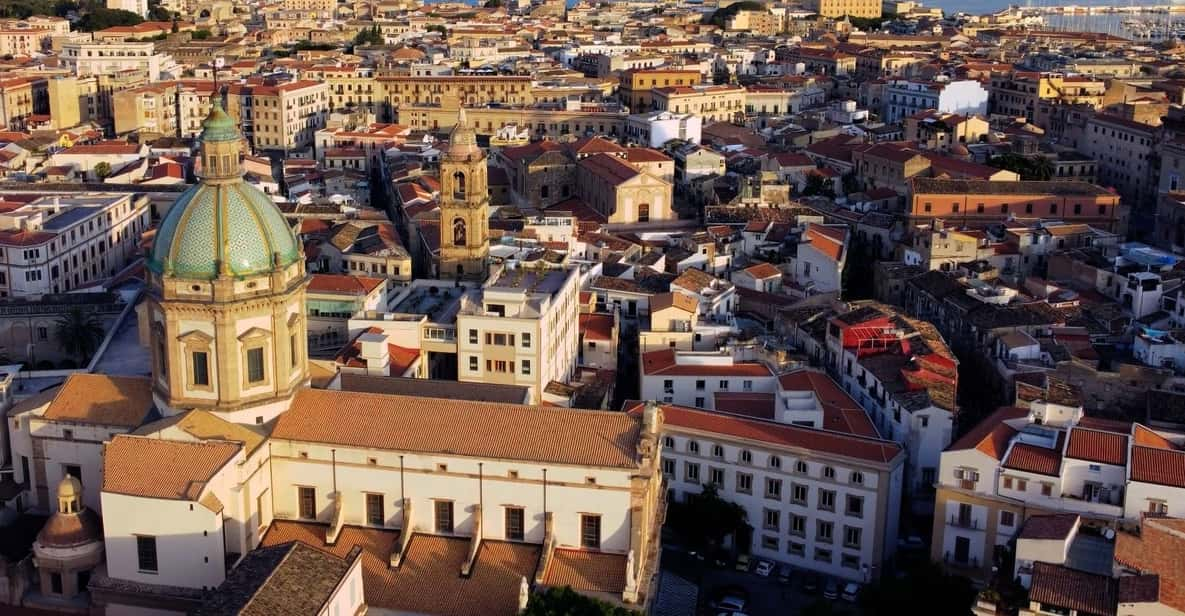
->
0;193;150;297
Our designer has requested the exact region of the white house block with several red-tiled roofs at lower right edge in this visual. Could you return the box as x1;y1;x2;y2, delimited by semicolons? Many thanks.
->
930;400;1185;579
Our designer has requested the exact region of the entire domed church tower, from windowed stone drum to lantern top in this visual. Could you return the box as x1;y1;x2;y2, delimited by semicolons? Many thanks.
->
142;101;308;423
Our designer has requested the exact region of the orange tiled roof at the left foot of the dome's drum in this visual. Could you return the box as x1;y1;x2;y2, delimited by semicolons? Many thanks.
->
43;373;153;428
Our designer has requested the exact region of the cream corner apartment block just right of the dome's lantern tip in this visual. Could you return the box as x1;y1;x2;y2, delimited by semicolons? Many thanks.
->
226;79;329;152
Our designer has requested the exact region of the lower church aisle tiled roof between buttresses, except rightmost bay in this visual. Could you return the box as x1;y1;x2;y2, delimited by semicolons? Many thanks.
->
261;520;540;616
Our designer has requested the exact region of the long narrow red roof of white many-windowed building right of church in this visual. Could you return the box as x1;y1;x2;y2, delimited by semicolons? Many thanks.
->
628;403;904;463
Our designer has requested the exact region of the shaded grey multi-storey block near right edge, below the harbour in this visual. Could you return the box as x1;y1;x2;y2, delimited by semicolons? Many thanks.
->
1078;114;1160;214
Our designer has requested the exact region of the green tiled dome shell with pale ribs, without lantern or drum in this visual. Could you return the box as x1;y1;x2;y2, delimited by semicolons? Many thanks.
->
148;180;301;280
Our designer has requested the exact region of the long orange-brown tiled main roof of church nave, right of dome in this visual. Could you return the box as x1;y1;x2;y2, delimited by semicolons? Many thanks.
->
271;390;641;468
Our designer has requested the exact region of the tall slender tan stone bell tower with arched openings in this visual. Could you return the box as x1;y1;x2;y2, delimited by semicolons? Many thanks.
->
438;108;489;281
